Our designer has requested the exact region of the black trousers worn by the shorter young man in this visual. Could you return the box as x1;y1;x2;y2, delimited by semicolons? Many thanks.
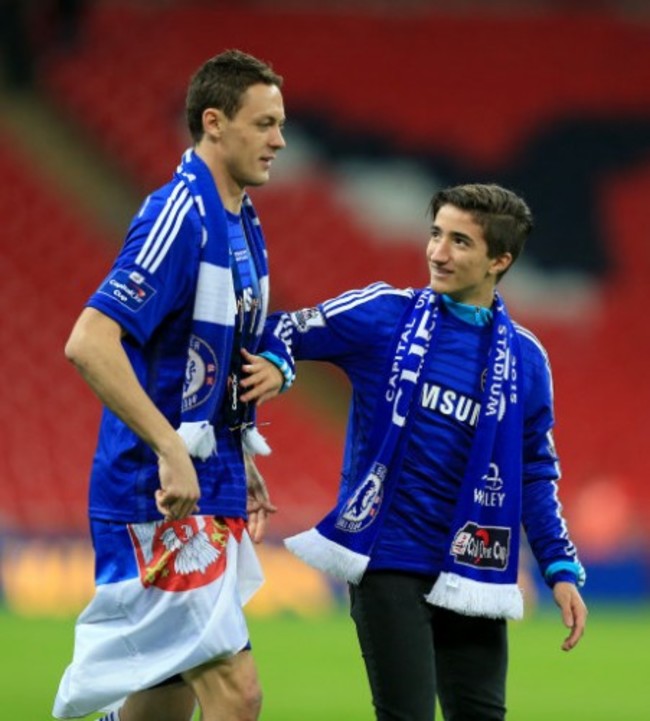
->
350;571;508;721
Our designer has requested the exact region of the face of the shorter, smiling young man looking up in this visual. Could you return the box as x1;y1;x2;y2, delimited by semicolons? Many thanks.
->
427;204;512;308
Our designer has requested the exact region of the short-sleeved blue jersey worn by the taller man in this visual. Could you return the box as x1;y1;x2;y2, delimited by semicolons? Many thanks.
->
81;181;252;523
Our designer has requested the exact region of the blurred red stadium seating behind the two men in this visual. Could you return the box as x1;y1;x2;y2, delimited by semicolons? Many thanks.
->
5;3;650;534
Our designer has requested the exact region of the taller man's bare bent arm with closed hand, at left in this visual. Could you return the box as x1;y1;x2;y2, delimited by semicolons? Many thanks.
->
65;308;200;519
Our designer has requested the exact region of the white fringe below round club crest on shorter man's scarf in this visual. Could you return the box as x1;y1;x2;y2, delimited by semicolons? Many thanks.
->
284;528;370;584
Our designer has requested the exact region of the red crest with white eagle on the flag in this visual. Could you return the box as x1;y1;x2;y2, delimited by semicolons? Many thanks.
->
128;516;230;592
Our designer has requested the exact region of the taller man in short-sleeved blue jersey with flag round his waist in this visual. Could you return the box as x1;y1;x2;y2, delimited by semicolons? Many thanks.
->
53;50;291;721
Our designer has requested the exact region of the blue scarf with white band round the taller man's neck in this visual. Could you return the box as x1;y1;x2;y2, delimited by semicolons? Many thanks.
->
175;149;269;460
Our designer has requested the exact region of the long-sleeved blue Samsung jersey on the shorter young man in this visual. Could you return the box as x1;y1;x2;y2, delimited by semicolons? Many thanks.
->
265;283;575;575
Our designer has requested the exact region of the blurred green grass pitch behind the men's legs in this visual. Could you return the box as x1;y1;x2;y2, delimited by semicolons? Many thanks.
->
0;606;650;721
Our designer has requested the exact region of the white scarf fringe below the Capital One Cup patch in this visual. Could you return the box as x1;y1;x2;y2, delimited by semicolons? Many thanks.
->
426;571;524;621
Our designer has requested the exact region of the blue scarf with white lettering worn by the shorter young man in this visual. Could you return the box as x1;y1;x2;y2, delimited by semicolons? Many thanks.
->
285;289;523;618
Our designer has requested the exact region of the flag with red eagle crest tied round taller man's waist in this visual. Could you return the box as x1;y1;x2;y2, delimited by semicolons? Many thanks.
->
52;516;263;718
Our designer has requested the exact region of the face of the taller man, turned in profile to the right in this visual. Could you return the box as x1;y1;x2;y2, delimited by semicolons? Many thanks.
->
219;83;286;190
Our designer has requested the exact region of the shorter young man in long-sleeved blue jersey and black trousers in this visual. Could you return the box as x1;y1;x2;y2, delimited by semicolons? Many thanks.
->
260;184;587;721
